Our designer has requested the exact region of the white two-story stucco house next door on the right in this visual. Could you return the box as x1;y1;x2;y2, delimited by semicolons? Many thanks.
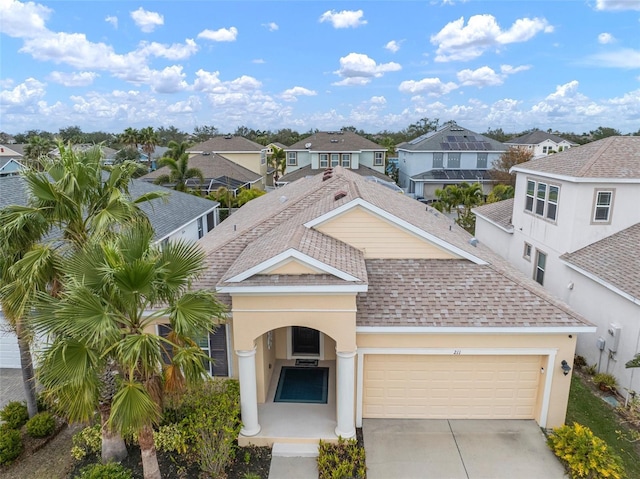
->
474;136;640;395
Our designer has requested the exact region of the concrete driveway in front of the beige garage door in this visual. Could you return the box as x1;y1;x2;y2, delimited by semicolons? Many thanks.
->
362;419;566;479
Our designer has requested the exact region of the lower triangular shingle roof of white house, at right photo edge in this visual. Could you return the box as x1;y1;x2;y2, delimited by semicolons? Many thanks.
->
560;223;640;299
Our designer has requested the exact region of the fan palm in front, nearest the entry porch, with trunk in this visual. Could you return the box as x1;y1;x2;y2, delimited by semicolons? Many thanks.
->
35;222;224;479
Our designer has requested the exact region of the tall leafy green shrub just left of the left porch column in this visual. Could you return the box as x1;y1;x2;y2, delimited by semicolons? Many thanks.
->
181;379;241;477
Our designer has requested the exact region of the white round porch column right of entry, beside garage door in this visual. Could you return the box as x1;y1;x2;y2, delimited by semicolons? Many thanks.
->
336;351;356;438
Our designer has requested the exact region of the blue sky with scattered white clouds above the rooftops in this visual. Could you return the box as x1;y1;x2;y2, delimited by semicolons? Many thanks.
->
0;0;640;133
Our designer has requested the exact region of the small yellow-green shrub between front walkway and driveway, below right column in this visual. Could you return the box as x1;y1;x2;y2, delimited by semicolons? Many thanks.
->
318;437;367;479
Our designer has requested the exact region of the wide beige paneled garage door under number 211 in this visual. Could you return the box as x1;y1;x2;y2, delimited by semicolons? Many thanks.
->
362;354;542;419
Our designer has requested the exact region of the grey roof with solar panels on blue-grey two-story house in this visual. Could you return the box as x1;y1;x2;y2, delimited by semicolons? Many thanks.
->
396;124;507;151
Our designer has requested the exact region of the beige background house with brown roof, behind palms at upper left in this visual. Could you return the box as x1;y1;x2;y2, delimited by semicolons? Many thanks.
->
187;135;267;189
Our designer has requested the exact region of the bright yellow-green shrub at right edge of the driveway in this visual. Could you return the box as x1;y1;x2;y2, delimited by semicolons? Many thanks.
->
547;423;626;479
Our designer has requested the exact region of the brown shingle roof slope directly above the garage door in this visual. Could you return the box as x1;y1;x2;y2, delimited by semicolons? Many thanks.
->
356;259;584;327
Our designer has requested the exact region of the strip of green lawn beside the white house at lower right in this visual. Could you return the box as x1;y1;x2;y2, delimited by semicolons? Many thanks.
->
566;376;640;478
